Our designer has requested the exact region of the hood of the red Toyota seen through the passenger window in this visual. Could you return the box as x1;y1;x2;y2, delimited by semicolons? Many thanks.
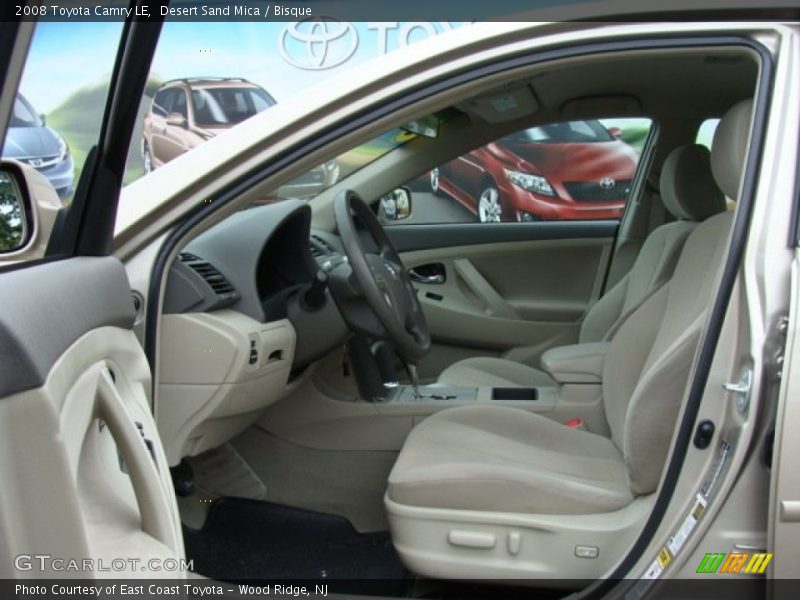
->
500;140;636;181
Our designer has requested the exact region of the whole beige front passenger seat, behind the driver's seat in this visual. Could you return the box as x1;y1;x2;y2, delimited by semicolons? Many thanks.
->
439;144;725;387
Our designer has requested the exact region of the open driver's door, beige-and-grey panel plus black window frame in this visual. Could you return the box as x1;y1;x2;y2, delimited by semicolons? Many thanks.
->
0;15;178;579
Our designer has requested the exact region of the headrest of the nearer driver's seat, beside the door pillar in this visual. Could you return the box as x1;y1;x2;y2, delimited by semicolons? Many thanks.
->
711;100;753;200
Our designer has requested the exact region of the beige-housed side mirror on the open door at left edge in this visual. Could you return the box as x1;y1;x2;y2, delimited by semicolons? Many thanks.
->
0;159;63;266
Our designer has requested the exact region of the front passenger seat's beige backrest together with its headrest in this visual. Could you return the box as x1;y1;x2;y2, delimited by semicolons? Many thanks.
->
578;144;725;344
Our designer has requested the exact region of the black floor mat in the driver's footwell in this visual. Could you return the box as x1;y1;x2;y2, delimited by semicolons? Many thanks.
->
184;498;408;595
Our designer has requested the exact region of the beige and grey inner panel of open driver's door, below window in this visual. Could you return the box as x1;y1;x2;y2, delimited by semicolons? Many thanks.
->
0;257;184;578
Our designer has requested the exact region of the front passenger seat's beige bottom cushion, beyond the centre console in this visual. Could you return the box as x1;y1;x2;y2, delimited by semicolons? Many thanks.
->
439;356;558;387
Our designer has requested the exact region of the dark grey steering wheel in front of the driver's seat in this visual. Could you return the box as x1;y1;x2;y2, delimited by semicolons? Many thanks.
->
333;190;431;364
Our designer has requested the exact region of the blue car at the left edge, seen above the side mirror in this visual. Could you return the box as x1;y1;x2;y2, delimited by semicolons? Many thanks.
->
2;94;75;200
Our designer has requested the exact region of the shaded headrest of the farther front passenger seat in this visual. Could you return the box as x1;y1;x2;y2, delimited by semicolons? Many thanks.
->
660;144;725;221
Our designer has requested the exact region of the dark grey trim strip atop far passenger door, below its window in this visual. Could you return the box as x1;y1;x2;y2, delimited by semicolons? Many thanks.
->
385;221;619;252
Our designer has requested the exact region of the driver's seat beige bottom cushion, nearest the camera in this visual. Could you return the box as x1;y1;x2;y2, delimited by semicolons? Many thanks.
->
388;405;633;514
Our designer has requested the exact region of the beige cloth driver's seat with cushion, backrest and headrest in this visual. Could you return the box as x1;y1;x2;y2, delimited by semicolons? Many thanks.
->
387;102;751;516
